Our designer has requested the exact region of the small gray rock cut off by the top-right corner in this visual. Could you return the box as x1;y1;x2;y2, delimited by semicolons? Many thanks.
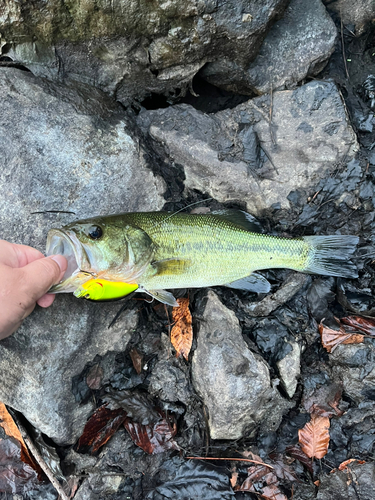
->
323;0;375;35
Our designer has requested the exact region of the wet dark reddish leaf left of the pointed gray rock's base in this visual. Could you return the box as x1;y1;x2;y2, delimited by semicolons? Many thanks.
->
124;412;180;455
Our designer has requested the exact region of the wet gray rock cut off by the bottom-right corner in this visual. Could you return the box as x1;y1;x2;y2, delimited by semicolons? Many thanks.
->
316;463;375;500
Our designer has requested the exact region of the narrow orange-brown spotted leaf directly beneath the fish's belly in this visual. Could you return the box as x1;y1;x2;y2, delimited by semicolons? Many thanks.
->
171;299;193;360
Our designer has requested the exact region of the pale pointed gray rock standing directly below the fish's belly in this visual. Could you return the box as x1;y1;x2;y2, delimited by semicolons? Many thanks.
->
192;291;288;439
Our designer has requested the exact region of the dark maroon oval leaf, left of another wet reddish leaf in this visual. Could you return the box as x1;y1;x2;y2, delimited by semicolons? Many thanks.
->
77;405;126;453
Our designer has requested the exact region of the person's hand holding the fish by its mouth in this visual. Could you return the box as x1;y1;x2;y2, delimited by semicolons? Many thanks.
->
0;240;67;339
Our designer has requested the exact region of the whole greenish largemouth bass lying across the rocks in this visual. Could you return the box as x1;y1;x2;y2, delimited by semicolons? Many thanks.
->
46;210;358;307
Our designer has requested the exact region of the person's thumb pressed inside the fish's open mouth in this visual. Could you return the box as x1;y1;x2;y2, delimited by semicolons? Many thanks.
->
22;255;68;302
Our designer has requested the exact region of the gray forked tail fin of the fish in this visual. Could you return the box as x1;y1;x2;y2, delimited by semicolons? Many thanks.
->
303;235;359;278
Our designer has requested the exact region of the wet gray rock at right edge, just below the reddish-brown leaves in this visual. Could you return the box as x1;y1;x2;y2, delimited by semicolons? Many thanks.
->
329;342;375;404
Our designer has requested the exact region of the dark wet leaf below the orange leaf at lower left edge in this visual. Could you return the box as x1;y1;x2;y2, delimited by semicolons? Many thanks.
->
0;437;38;494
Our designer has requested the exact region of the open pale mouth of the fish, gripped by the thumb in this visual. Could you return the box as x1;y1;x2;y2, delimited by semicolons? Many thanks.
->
46;229;92;293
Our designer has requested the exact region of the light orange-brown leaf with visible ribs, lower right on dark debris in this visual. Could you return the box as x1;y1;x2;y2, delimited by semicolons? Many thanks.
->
298;414;330;459
